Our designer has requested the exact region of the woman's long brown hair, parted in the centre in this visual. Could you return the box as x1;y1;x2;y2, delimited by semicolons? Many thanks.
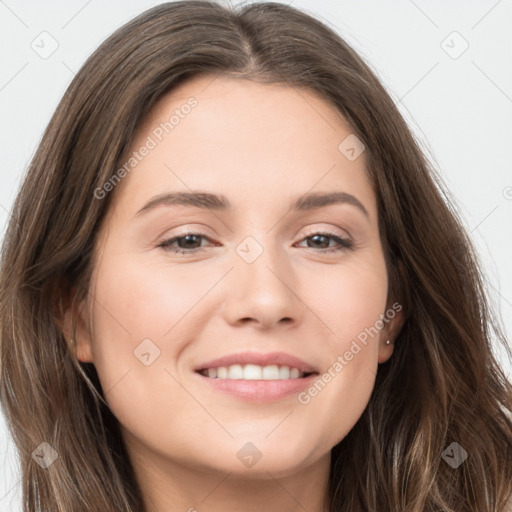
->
0;1;512;512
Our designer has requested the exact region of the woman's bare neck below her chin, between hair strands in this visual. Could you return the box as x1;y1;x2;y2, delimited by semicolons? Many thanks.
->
129;436;330;512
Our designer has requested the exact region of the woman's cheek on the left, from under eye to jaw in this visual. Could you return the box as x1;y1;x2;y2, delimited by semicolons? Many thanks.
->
85;251;205;438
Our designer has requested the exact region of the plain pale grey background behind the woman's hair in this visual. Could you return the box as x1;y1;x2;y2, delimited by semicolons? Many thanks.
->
0;0;512;512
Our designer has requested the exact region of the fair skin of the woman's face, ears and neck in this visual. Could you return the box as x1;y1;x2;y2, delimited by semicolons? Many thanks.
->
67;76;401;512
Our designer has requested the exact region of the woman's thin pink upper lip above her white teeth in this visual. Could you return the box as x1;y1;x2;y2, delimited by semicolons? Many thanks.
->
194;352;317;373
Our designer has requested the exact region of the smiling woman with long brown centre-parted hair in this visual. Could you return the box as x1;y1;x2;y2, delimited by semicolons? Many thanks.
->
0;1;512;512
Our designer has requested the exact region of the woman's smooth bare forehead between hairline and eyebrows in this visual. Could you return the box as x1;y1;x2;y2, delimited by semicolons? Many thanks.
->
108;75;375;220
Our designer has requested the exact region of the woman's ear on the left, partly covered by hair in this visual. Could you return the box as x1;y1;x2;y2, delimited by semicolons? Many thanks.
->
60;287;94;363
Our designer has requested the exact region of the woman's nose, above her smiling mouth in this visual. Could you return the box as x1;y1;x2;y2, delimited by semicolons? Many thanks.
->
223;244;304;330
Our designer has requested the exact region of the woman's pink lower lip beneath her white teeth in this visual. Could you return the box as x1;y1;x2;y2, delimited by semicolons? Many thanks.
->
197;373;318;402
